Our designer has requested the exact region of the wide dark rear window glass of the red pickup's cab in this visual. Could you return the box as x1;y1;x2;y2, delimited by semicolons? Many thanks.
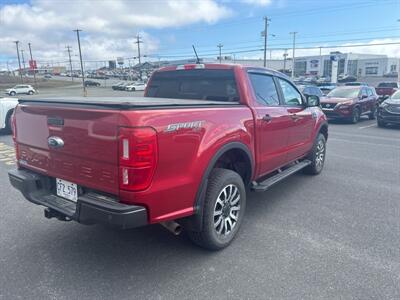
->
147;69;240;102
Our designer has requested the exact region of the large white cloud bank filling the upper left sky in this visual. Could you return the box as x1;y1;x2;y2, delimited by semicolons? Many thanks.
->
0;0;232;67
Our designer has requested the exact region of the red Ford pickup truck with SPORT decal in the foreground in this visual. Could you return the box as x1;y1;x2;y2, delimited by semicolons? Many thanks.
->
9;64;328;250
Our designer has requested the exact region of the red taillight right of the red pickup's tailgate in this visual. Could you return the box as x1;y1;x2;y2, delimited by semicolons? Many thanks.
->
119;127;157;191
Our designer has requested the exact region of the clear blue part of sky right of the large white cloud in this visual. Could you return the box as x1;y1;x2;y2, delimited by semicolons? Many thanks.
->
150;0;400;56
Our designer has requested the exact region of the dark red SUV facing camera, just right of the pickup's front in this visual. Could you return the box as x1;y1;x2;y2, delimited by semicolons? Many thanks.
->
321;86;378;123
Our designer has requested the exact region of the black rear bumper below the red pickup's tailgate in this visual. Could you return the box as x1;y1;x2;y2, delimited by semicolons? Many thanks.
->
8;169;148;229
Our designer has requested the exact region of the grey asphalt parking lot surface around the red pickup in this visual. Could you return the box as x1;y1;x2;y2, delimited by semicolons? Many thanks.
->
0;110;400;299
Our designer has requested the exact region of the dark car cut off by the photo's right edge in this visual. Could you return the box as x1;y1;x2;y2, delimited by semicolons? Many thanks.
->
377;90;400;127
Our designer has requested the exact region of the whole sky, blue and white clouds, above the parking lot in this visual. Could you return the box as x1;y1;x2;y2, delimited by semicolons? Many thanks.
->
0;0;400;68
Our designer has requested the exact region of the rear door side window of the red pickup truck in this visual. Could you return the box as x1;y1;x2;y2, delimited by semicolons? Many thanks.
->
249;73;279;106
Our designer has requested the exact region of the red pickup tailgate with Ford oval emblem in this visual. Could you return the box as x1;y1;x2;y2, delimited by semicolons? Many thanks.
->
15;103;119;194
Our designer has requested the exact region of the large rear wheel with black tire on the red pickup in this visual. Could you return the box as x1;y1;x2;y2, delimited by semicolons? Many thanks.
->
188;169;246;251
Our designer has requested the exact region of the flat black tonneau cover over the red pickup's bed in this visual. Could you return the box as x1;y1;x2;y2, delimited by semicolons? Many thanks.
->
18;97;239;109
